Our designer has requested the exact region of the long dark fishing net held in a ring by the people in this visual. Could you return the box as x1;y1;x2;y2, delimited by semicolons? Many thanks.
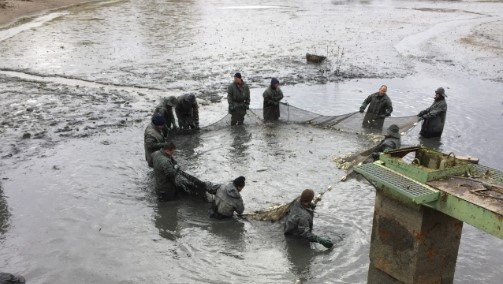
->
179;103;417;222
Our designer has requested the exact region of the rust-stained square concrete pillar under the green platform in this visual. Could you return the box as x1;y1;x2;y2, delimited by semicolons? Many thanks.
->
368;190;463;284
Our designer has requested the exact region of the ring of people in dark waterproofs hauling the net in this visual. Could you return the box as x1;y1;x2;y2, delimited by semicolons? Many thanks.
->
144;73;447;248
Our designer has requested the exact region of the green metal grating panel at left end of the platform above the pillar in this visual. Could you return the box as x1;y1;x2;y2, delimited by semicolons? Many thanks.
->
355;163;438;203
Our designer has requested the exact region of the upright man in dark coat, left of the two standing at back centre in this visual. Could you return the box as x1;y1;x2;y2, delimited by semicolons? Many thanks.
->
227;73;250;125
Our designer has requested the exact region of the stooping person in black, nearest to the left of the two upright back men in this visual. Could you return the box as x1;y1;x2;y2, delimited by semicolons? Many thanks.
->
175;94;199;130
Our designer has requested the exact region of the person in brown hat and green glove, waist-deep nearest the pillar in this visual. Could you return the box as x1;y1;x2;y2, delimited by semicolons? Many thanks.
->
283;189;333;248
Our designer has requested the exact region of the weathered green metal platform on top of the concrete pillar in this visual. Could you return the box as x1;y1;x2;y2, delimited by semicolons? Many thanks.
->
355;146;503;239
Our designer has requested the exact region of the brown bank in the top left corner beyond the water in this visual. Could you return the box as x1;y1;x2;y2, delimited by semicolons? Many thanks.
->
0;0;100;29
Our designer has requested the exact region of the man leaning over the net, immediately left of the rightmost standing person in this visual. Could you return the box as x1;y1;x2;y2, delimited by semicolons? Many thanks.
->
360;85;393;129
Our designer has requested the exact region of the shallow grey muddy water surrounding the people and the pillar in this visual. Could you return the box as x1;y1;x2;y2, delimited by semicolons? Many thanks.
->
0;1;503;283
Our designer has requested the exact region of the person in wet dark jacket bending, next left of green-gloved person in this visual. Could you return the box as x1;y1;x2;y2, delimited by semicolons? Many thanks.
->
207;176;245;219
